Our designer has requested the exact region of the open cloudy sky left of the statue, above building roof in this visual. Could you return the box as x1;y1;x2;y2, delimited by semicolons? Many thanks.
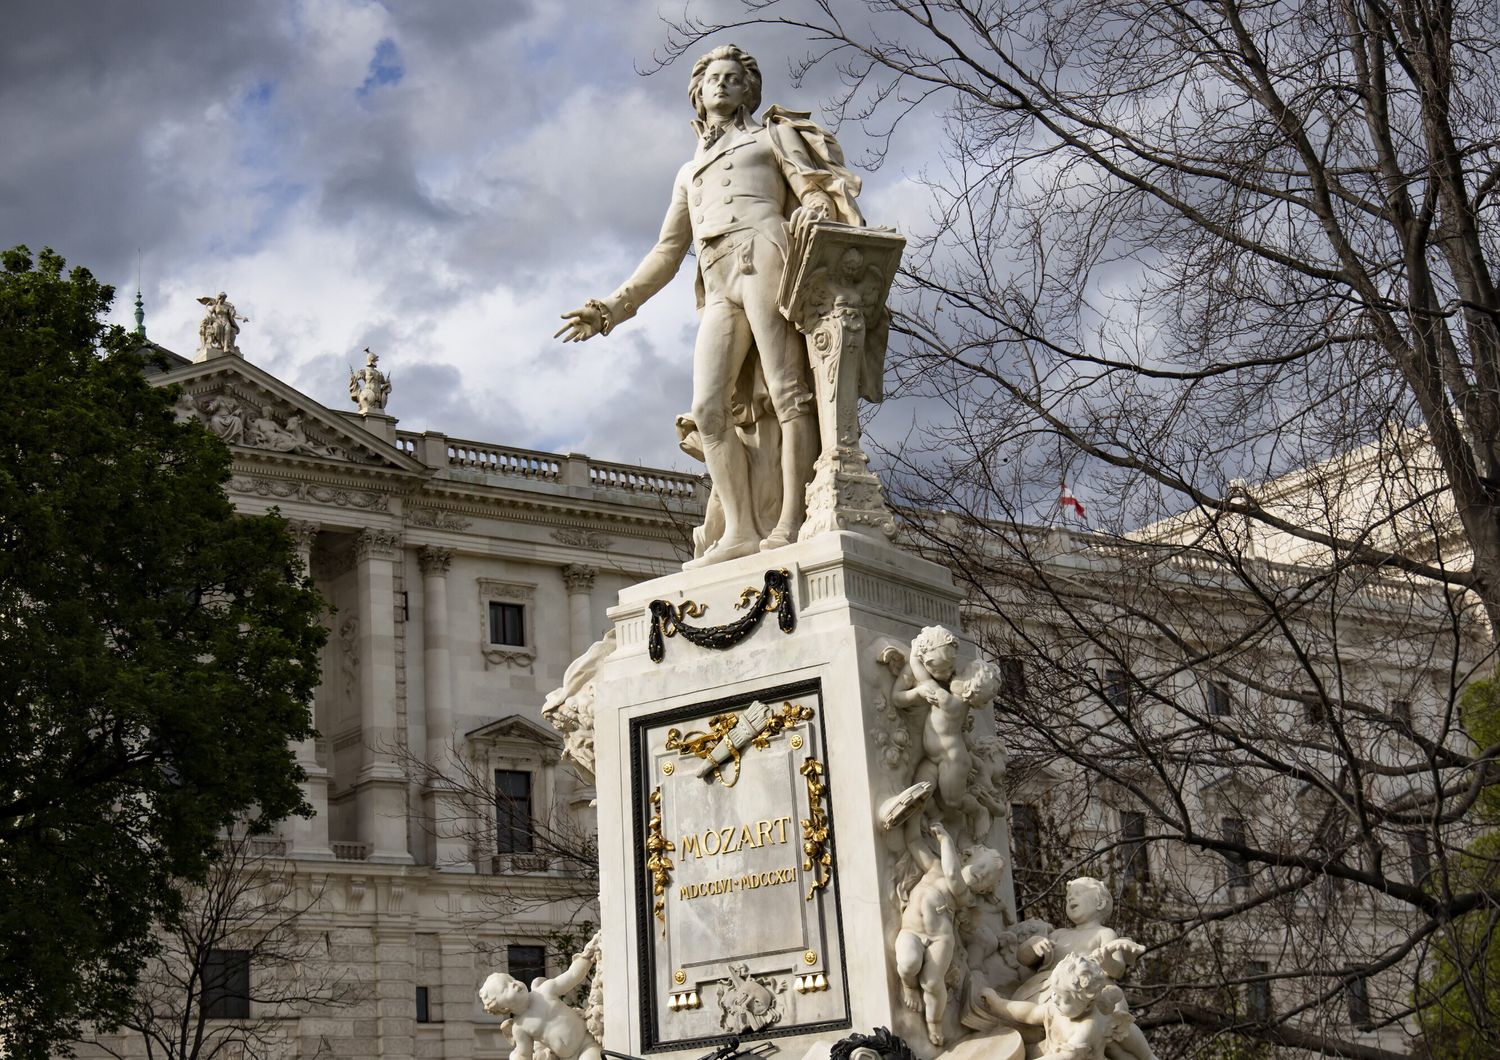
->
0;0;930;468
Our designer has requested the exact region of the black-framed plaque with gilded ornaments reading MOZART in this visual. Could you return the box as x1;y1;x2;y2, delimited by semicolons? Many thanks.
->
632;682;849;1048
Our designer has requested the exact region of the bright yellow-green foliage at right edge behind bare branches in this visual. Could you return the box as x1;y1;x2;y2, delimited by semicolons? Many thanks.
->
1418;678;1500;1060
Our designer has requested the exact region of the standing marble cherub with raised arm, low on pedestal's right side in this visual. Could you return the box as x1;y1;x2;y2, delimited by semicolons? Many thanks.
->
896;822;1005;1045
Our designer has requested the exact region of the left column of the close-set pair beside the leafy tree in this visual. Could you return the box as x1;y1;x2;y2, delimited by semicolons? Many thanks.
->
354;529;411;862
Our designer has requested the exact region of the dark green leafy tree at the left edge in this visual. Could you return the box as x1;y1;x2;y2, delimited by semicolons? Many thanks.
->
0;247;326;1059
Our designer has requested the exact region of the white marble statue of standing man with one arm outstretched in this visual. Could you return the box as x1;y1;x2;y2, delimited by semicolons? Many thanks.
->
558;45;864;567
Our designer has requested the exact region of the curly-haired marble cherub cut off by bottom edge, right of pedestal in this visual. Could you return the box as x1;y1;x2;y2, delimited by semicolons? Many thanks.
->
981;954;1157;1060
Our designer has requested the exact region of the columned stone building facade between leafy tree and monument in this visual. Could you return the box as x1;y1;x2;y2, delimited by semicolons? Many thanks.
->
87;341;705;1060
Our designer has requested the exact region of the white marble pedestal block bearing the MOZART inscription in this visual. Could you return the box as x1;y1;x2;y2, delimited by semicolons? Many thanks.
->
594;531;1014;1057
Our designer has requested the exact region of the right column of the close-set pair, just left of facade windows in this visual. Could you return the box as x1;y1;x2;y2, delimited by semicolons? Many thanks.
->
417;544;474;873
